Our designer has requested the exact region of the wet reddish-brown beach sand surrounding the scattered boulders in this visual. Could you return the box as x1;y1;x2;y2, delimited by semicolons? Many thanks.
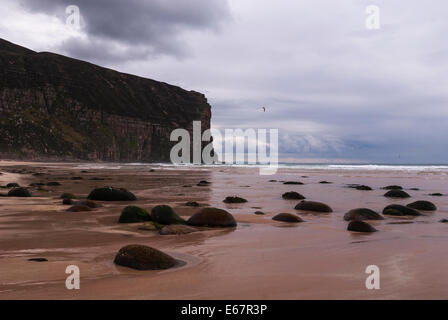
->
0;162;448;299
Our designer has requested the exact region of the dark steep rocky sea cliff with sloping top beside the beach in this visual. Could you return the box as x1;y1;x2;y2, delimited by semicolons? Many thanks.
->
0;39;211;162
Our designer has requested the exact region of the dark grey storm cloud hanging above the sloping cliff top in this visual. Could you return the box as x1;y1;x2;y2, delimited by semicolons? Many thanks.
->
18;0;230;63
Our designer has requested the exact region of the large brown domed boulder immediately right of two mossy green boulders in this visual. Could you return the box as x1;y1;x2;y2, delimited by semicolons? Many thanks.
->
187;208;237;228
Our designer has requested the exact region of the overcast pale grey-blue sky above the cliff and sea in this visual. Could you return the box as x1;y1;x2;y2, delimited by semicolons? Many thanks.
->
0;0;448;163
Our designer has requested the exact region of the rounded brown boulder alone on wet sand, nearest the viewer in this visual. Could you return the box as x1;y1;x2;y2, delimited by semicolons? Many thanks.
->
114;244;176;270
